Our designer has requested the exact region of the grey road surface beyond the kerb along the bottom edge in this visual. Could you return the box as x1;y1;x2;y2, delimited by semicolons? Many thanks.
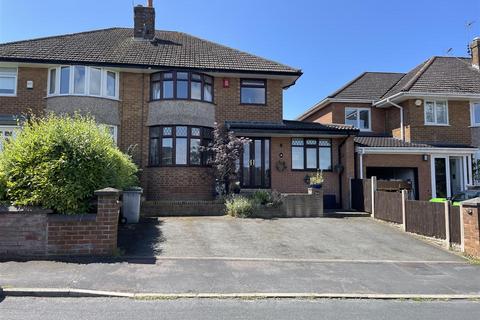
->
0;298;480;320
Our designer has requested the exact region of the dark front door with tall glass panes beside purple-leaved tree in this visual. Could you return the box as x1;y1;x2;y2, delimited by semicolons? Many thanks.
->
240;138;270;188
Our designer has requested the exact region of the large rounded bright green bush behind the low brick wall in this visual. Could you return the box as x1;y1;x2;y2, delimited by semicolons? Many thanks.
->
0;115;138;214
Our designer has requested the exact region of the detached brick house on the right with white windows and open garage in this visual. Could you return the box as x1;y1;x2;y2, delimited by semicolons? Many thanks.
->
298;38;480;200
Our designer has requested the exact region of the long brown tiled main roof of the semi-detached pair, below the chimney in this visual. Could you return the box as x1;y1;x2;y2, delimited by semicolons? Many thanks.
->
0;28;301;76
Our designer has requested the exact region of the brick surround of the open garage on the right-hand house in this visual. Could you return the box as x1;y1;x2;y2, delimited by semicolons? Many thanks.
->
357;154;432;200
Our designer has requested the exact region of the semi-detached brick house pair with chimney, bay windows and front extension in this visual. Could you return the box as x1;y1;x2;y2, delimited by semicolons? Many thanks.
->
0;1;358;207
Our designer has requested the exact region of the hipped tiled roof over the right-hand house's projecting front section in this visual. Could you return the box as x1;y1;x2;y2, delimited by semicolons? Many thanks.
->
382;57;480;98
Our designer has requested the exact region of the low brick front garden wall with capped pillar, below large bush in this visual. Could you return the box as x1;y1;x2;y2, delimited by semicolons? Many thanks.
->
0;188;120;256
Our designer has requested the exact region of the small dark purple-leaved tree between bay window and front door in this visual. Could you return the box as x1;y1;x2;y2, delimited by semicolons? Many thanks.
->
206;123;250;195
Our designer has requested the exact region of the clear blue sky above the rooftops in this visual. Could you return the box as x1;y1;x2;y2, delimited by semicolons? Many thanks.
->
0;0;480;119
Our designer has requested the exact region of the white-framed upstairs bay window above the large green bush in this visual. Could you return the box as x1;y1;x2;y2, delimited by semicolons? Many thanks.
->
48;66;120;99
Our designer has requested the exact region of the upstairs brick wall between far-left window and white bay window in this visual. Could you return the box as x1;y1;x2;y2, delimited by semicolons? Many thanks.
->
0;68;48;115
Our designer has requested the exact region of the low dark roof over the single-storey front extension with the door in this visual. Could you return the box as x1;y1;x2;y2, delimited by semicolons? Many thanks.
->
225;120;358;135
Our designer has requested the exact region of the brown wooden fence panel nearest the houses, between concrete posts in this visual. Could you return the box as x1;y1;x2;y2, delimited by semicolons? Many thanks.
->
375;191;403;223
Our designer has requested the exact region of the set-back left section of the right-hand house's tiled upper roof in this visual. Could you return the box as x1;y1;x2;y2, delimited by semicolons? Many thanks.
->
328;72;405;101
